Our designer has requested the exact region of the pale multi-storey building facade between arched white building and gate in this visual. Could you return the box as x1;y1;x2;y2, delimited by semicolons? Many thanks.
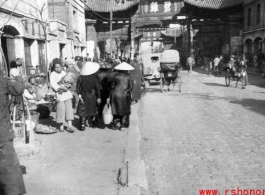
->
48;0;87;59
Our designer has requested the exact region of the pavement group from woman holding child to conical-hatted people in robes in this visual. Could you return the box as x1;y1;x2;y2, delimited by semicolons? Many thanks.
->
47;54;144;132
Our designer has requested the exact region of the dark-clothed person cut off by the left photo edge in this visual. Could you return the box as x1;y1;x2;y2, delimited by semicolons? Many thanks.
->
0;75;26;195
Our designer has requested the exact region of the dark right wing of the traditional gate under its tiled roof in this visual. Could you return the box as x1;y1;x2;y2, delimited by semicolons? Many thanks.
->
184;0;243;56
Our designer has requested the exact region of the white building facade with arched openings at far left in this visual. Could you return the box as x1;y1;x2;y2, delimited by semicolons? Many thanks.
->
0;0;48;76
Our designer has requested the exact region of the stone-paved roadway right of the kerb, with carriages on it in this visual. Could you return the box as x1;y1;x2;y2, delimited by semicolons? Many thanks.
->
138;71;265;195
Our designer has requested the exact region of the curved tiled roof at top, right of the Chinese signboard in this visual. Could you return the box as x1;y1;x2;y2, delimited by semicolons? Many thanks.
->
184;0;241;9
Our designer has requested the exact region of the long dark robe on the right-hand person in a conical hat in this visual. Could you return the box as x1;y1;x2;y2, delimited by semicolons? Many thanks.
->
111;72;133;116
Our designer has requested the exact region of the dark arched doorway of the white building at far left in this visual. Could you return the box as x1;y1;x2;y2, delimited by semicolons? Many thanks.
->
0;25;20;75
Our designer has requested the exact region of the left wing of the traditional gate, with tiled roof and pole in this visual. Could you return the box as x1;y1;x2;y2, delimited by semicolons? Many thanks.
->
86;0;139;57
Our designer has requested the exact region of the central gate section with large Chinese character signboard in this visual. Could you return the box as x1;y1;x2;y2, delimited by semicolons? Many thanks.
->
132;0;184;55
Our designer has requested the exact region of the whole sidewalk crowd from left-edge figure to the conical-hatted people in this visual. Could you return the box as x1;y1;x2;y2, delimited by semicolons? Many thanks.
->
0;54;143;195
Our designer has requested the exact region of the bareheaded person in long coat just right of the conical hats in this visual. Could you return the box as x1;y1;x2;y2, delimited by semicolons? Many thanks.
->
130;53;144;102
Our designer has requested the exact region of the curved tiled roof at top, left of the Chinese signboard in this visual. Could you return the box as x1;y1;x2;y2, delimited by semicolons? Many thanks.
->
86;0;140;12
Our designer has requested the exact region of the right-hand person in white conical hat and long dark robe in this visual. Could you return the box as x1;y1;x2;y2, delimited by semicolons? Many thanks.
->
107;62;133;130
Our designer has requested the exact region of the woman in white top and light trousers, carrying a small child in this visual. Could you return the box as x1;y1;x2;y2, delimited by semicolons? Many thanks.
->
50;59;74;133
